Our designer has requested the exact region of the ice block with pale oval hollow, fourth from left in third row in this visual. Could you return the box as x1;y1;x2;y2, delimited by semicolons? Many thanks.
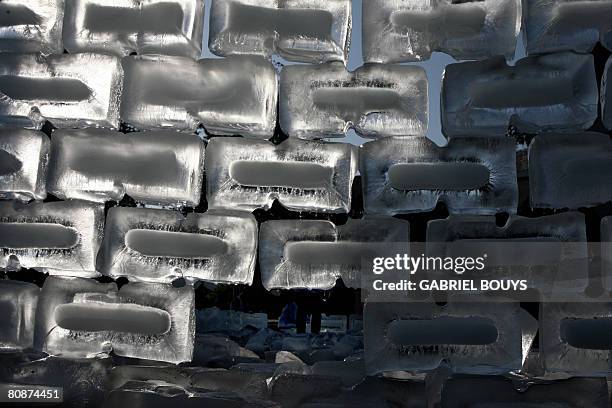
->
359;138;518;215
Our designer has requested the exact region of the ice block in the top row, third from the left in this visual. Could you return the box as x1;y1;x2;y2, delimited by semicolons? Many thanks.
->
208;0;351;63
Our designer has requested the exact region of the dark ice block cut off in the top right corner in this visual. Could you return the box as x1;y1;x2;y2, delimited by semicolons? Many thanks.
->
523;0;612;54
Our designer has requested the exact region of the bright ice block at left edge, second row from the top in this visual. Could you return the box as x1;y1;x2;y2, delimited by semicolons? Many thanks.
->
0;53;123;128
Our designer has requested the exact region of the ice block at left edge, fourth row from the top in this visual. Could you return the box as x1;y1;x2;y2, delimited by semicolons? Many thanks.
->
0;201;104;276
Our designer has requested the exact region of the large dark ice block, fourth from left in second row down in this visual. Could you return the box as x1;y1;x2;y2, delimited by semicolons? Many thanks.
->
441;53;599;138
